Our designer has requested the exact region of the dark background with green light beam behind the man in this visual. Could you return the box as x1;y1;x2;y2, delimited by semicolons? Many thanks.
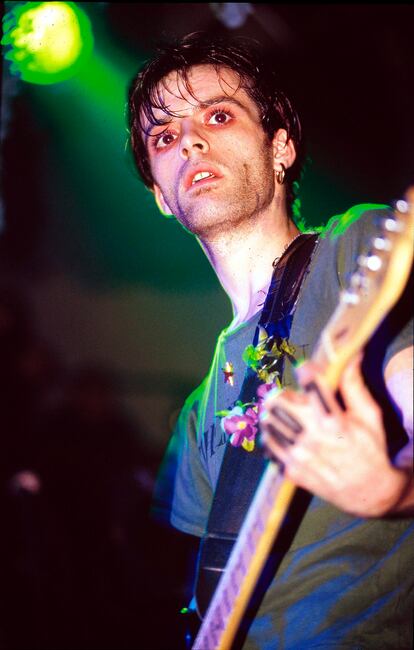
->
0;2;414;650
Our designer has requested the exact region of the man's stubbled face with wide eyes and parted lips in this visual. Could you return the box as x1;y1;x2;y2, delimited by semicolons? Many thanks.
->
147;65;275;239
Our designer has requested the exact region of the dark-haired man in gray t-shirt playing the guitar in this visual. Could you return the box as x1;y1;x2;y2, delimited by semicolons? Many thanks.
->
130;34;414;650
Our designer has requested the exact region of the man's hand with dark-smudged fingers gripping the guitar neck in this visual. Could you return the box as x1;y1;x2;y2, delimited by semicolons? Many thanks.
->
260;358;410;517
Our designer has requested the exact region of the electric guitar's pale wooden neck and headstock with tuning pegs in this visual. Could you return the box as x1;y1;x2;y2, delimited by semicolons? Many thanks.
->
192;186;414;650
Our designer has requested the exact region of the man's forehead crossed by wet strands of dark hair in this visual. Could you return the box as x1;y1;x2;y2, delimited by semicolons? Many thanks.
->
149;65;254;119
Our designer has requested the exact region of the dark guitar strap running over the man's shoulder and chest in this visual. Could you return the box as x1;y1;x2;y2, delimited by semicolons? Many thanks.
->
195;233;317;616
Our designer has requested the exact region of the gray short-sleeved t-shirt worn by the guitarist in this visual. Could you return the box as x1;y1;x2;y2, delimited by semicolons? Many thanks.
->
154;206;414;650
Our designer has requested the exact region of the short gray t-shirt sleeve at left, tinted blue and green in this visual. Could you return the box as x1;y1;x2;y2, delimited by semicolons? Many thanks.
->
152;384;212;537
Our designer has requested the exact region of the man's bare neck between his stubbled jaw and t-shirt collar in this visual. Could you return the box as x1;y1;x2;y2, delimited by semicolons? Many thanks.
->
200;208;299;329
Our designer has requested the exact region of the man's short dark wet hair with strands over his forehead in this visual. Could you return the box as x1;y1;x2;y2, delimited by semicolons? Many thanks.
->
129;32;304;215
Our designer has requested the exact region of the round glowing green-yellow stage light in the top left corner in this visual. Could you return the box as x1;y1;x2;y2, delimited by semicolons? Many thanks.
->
1;2;93;84
